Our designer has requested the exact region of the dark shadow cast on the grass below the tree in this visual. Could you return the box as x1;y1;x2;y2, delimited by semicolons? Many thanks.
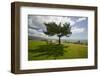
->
29;44;68;59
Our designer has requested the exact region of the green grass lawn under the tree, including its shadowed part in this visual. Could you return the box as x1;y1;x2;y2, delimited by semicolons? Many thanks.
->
28;40;88;60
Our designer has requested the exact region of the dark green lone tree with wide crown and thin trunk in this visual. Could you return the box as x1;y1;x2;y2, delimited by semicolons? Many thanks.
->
44;22;72;45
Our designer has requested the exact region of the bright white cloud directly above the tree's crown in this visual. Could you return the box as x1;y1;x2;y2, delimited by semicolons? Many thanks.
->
30;16;75;26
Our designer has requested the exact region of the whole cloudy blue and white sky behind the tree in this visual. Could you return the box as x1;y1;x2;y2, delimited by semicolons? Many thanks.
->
28;15;88;40
